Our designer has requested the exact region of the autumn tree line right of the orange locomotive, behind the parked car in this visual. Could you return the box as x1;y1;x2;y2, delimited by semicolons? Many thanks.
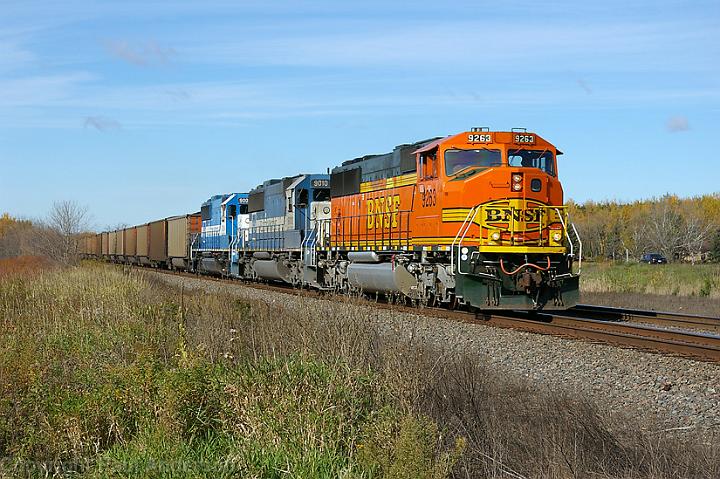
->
569;193;720;263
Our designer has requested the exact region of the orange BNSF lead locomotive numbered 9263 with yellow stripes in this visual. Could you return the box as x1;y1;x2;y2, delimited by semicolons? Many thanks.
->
314;128;582;309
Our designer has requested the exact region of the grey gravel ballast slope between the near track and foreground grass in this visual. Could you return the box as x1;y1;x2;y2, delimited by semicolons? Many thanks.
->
149;273;720;437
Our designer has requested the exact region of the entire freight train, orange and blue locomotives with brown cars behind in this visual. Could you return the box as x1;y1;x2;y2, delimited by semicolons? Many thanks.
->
83;128;582;310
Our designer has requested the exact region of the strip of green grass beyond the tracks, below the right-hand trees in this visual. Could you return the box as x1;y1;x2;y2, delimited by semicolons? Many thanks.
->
580;262;720;298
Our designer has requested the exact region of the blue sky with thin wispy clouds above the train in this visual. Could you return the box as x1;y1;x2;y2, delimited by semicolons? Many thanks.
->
0;0;720;228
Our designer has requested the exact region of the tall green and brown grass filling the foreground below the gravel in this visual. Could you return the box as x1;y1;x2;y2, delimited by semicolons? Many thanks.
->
0;267;720;478
